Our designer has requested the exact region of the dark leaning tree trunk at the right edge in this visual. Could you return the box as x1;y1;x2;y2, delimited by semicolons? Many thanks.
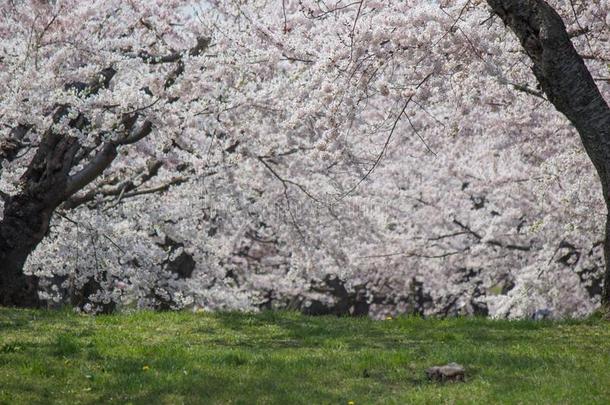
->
487;0;610;306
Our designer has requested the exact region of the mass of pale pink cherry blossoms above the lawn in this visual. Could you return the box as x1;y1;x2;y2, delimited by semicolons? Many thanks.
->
0;0;610;316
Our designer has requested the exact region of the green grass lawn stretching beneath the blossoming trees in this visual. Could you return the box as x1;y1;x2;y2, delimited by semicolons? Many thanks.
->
0;308;610;405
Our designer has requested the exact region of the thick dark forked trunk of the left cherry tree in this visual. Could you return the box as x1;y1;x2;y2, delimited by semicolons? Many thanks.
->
0;64;159;307
